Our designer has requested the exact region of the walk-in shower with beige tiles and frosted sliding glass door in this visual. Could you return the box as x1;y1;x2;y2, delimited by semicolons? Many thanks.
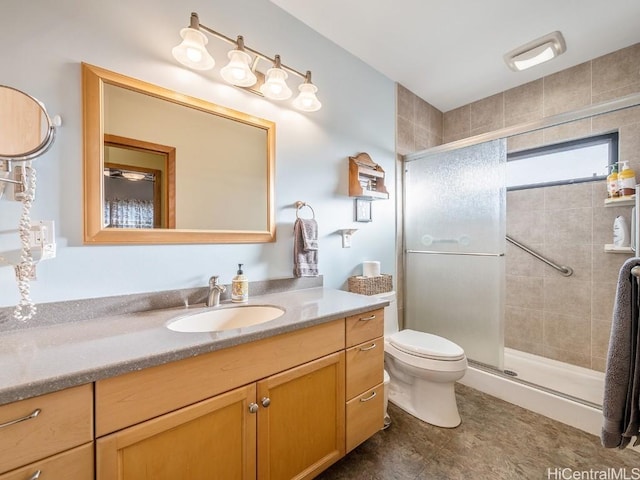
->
402;95;640;428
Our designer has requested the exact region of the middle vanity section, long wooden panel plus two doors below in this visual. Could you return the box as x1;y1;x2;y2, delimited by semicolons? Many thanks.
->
96;320;346;480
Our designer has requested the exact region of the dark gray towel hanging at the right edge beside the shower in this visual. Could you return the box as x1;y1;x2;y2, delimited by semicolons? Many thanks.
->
600;257;640;448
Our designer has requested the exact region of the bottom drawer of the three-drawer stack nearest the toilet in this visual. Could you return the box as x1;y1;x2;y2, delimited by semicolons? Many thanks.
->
347;384;384;452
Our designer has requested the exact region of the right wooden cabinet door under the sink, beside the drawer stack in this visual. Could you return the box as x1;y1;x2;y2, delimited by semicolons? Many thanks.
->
257;352;345;480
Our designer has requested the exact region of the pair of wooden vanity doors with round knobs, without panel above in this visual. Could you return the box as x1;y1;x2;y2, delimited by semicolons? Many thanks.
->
96;352;345;480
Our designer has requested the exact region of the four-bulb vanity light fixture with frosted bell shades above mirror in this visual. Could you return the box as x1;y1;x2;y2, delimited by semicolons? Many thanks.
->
172;13;322;112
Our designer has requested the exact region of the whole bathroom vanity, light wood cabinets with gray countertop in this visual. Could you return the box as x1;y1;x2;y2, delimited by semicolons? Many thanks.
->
0;288;385;480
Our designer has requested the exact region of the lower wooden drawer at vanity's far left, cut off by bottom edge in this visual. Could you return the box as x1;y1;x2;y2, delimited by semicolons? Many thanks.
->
0;443;94;480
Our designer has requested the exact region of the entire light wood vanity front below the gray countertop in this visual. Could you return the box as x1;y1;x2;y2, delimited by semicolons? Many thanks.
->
0;309;384;480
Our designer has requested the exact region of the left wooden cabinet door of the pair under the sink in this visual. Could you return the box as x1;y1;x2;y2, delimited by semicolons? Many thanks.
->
96;384;256;480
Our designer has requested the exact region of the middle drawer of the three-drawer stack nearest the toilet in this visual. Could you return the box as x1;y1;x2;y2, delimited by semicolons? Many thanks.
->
347;337;384;400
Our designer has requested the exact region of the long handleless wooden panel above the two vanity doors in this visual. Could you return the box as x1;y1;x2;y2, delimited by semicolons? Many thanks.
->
96;319;345;437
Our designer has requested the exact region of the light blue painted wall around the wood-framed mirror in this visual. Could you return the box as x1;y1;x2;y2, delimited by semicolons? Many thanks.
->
0;0;395;306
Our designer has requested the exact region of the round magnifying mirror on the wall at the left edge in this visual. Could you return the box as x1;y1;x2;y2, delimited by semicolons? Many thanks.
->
0;85;60;162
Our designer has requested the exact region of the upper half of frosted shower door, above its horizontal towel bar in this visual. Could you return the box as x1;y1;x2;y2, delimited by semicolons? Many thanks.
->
405;139;506;253
